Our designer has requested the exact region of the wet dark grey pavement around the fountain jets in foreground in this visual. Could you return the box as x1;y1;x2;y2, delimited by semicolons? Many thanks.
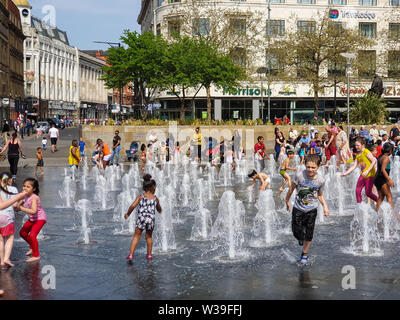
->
0;167;400;300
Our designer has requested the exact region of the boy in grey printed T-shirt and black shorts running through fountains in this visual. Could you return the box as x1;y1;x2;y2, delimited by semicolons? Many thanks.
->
286;154;329;265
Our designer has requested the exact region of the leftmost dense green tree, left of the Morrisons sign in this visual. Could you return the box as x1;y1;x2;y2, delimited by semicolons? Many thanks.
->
101;30;167;120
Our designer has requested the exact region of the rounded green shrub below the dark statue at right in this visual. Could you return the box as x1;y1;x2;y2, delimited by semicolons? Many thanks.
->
350;94;389;125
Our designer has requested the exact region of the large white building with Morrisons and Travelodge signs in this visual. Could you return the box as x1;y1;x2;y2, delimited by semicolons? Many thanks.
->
138;0;400;121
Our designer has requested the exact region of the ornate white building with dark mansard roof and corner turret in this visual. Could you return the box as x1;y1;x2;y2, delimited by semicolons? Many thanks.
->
14;0;79;120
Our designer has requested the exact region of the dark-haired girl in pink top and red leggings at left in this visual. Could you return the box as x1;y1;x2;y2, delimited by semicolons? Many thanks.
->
18;178;47;262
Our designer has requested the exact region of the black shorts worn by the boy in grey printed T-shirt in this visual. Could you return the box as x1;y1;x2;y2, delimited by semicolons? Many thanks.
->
292;208;317;241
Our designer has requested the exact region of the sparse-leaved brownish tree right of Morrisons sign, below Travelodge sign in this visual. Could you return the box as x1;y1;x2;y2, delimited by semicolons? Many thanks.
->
270;11;374;117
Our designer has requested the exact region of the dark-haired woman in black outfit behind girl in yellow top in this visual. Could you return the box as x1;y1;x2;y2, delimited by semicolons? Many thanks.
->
374;143;394;212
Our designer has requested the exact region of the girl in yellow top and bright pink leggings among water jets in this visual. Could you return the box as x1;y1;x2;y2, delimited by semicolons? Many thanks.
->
342;138;378;203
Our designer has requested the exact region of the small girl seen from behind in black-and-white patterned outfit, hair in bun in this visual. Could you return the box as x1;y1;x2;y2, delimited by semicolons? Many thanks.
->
125;174;162;261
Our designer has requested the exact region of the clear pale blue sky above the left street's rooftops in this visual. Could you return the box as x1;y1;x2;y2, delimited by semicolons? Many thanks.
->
28;0;141;50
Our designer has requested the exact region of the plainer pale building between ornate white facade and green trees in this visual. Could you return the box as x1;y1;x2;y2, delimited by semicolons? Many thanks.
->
77;51;112;119
